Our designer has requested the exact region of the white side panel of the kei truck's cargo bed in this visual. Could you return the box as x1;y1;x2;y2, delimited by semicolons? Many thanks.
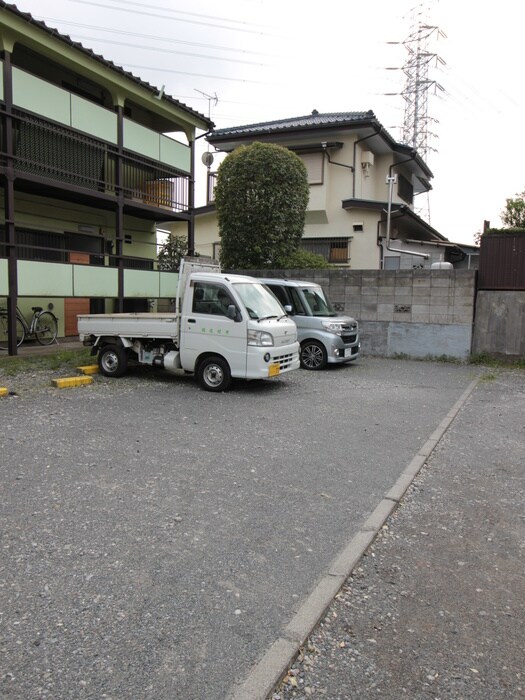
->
78;313;179;340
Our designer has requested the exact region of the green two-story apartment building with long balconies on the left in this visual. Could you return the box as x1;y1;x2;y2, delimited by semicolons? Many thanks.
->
0;0;213;352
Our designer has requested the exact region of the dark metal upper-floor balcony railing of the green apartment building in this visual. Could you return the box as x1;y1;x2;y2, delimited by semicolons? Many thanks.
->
1;114;189;212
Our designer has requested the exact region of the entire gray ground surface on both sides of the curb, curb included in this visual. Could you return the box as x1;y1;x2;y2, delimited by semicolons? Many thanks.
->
0;358;525;700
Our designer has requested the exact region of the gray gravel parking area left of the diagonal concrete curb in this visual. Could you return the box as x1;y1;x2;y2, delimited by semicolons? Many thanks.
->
0;358;478;700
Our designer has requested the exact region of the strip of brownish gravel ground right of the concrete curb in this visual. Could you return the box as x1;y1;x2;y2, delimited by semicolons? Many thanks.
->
272;371;525;700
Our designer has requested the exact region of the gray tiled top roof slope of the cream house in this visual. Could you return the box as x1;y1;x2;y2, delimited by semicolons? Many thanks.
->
208;110;376;141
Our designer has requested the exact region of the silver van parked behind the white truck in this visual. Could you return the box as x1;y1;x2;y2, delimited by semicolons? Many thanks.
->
260;278;361;369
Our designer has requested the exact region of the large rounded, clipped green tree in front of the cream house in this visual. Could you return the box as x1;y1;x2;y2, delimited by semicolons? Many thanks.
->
215;143;309;269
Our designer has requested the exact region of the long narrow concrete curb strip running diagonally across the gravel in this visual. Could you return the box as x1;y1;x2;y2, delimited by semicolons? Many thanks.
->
229;375;481;700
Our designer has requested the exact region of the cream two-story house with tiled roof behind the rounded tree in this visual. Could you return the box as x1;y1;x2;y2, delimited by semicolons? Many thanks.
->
174;110;465;270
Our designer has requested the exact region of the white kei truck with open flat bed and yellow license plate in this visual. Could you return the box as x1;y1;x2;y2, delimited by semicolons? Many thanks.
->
78;258;300;391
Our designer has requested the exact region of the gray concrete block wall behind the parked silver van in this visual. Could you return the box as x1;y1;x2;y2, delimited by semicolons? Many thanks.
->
244;269;476;360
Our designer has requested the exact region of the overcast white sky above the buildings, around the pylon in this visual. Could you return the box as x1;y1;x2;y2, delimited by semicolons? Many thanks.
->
11;0;525;243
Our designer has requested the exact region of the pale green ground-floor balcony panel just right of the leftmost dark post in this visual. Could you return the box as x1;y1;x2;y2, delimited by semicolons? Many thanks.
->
18;260;73;297
